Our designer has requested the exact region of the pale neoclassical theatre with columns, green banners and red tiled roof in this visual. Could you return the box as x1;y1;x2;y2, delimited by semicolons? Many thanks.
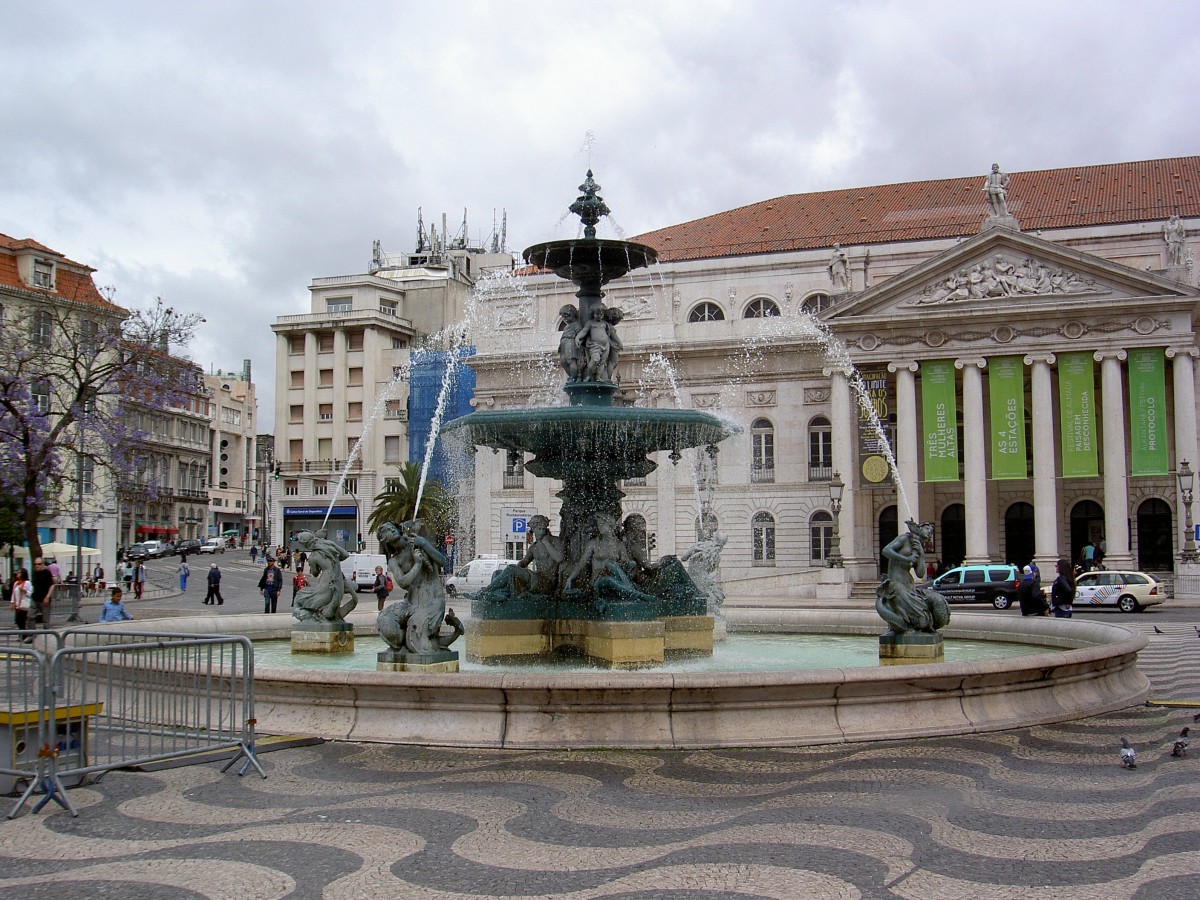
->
472;157;1200;589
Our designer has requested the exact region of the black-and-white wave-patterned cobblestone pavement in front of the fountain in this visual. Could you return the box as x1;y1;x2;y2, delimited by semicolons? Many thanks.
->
0;623;1200;900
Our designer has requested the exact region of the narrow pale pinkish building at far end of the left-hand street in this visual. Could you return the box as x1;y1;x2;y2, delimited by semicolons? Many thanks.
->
204;360;260;538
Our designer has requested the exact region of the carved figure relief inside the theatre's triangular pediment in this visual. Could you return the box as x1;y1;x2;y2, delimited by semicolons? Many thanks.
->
901;253;1108;306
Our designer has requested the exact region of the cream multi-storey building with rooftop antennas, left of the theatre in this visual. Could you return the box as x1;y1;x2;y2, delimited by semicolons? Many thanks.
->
270;222;512;551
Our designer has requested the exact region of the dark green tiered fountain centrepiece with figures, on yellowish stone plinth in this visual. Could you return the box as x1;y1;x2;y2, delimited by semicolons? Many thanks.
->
443;170;733;668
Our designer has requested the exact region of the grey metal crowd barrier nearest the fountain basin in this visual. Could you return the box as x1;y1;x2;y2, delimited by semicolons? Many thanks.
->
4;628;266;818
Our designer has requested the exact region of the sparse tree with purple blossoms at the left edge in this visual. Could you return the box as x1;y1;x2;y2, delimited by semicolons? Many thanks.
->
0;296;203;557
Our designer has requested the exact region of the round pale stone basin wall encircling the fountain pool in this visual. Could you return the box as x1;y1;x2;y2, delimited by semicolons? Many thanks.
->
113;610;1150;749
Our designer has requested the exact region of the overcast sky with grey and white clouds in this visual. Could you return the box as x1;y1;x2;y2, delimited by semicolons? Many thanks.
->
0;0;1200;431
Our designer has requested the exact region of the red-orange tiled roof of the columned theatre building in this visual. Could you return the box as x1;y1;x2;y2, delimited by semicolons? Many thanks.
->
631;156;1200;259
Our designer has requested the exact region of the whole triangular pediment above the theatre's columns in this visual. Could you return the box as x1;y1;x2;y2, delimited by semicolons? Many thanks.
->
829;229;1194;319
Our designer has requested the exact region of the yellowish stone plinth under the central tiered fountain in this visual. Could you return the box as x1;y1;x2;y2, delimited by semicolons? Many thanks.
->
467;616;714;668
